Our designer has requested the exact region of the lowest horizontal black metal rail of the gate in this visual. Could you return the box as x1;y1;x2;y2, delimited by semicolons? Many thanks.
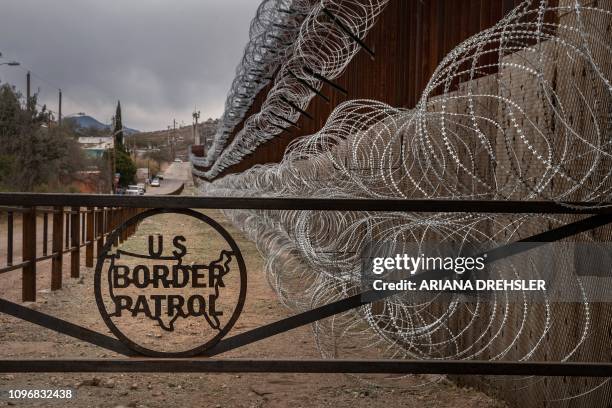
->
0;358;612;377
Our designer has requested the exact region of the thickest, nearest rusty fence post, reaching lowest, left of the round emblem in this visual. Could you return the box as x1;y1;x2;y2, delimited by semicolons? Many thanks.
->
21;207;36;302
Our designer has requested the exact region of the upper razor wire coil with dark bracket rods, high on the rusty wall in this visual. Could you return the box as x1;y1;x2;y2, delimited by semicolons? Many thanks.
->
203;0;388;174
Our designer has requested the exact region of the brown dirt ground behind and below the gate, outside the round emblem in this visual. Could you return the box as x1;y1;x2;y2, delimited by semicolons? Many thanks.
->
0;186;505;408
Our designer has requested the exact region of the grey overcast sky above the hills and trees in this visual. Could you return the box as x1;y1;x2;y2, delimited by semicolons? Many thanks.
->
0;0;260;130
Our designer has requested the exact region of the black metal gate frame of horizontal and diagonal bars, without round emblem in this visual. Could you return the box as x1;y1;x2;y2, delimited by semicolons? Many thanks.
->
0;193;612;377
